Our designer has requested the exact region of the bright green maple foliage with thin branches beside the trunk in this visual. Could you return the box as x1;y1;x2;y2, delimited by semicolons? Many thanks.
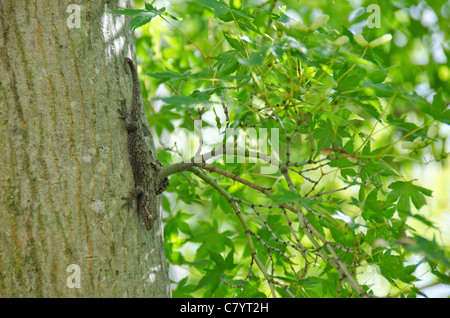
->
110;0;450;297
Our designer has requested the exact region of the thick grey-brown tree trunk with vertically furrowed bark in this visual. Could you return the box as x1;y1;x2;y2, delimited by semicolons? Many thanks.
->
0;0;170;297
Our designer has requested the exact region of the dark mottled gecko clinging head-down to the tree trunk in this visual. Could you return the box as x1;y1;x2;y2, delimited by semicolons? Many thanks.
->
118;58;169;230
